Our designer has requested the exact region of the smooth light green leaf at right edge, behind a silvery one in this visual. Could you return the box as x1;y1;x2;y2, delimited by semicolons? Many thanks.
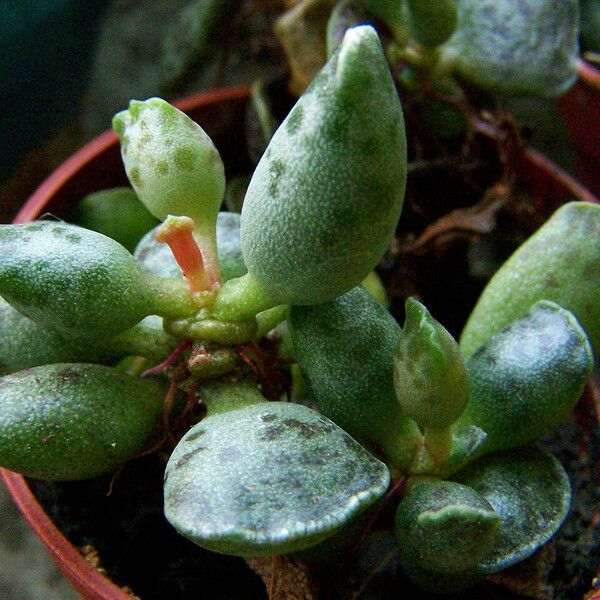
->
460;202;600;356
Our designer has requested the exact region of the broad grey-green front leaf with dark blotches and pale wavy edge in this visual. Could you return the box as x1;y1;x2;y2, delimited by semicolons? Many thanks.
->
165;402;389;556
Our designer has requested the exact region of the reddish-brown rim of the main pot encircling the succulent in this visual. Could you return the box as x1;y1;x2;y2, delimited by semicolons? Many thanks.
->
0;81;600;600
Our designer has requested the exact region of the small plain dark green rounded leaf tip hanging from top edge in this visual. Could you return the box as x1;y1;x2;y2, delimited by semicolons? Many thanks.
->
406;0;458;48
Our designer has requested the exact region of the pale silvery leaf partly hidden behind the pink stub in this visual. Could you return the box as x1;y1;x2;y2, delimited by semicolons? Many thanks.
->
133;212;246;281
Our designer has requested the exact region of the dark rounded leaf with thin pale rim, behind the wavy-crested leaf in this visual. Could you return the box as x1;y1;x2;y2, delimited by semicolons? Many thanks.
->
454;447;571;573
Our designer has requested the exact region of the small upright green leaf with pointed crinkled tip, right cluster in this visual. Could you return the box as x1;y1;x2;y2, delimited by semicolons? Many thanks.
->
394;298;469;430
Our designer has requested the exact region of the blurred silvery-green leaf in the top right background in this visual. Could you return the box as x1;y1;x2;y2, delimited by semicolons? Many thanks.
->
444;0;579;97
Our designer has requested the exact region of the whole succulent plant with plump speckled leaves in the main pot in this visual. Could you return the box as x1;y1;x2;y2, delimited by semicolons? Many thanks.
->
0;21;600;591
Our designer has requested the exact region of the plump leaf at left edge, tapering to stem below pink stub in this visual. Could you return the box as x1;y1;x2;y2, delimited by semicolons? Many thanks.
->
0;221;196;337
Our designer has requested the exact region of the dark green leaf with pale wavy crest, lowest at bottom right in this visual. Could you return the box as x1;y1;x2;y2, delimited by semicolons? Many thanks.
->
396;481;500;573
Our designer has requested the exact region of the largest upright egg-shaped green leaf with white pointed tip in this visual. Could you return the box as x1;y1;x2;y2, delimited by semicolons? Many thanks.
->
241;26;406;304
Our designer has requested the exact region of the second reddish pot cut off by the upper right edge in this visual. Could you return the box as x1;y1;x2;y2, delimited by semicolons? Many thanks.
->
556;59;600;195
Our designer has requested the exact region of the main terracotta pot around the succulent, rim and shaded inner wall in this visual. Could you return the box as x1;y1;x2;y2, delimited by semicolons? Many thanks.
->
0;87;600;600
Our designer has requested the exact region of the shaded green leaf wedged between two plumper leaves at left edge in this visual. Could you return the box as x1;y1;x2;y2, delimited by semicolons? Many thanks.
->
0;298;178;375
